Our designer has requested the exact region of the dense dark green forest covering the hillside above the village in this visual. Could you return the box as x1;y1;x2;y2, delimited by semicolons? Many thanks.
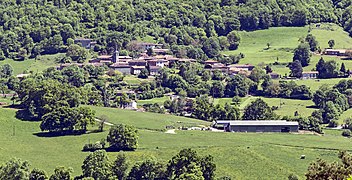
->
0;0;352;59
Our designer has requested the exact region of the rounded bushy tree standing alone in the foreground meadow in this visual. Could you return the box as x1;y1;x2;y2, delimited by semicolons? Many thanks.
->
107;124;138;150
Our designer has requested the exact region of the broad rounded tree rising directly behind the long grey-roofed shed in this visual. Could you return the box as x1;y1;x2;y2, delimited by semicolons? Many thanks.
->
242;98;276;120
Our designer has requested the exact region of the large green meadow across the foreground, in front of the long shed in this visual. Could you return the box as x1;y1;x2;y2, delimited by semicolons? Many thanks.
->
0;108;352;179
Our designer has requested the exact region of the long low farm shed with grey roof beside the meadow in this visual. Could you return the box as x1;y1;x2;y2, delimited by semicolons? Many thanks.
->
216;120;298;132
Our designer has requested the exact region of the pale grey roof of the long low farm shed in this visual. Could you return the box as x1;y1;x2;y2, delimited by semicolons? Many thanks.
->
216;120;298;126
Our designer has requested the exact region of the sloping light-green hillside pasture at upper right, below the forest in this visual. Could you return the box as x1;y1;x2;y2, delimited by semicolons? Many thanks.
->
223;24;352;75
